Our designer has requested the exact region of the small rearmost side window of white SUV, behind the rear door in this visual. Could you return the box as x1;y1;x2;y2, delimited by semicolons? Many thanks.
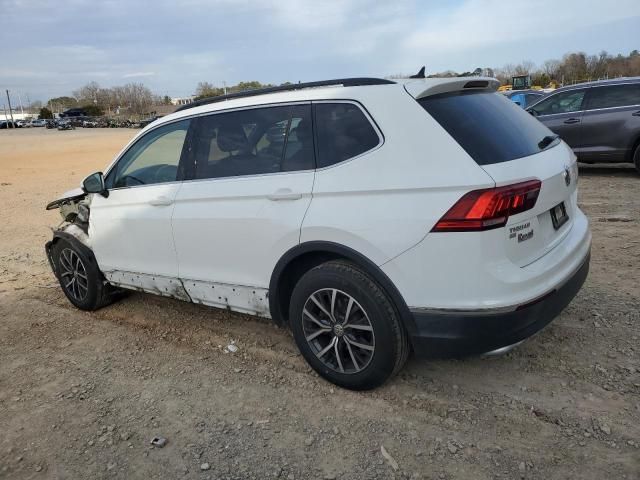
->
314;103;380;168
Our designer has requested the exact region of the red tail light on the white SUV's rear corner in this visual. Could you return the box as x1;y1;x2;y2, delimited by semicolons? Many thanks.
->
431;180;542;232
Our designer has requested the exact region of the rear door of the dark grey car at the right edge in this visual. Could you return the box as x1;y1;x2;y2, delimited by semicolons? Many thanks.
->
580;83;640;162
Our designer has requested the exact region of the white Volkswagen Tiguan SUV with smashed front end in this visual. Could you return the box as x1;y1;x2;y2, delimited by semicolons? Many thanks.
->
46;77;591;389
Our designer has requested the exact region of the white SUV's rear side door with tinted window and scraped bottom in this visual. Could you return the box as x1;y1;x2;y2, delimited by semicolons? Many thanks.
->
173;103;315;316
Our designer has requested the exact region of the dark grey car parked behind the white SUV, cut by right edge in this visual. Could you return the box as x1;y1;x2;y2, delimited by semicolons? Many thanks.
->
527;77;640;172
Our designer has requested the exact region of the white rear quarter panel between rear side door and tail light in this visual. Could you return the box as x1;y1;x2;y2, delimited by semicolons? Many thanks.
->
301;85;494;265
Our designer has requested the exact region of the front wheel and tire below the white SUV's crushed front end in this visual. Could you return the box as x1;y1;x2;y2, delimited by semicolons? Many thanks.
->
51;239;113;311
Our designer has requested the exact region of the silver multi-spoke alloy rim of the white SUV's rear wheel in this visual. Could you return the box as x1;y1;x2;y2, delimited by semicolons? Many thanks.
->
302;288;375;374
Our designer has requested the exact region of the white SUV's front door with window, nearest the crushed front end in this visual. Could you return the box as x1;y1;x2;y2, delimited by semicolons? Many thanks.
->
89;120;190;298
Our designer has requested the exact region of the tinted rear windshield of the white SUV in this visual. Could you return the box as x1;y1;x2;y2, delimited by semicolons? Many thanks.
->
418;92;553;165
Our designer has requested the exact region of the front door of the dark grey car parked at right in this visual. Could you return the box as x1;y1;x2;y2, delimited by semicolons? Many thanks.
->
527;88;587;151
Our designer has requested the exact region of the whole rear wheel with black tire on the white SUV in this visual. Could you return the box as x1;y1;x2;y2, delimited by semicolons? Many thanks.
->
289;261;409;390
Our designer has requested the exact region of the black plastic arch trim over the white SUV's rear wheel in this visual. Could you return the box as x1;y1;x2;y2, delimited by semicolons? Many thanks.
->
269;241;415;335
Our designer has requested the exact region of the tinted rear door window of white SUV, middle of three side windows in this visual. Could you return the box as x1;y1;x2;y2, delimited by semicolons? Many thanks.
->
194;105;314;179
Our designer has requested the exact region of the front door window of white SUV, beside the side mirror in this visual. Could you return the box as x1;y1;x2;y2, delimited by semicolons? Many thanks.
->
105;120;190;188
